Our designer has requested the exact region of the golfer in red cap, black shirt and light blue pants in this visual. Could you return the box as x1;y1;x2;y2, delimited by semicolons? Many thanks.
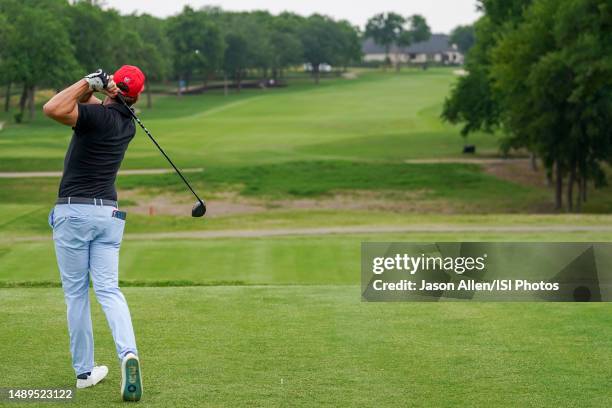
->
43;65;145;401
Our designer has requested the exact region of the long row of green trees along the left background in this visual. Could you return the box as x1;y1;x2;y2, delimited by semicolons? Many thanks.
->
0;0;361;116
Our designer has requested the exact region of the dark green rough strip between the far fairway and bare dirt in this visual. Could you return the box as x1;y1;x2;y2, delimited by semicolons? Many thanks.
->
0;161;537;203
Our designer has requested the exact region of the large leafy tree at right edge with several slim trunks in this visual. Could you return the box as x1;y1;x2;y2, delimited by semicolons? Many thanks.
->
492;0;612;211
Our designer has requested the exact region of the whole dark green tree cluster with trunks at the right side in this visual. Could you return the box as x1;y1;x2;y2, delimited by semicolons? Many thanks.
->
442;0;612;211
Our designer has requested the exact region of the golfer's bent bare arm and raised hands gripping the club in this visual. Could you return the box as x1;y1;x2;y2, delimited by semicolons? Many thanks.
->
43;70;119;127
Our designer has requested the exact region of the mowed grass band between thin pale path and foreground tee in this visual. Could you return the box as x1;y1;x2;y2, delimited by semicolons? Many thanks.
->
0;231;611;286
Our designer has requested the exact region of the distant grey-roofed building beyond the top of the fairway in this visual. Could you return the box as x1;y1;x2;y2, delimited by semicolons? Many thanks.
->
362;34;464;65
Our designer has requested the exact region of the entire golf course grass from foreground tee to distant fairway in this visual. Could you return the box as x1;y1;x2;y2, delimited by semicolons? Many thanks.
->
0;68;612;407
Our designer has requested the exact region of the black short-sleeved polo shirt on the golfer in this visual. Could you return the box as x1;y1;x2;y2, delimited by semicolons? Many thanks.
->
58;103;136;200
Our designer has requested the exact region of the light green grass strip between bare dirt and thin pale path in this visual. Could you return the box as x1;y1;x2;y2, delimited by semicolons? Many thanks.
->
0;202;612;237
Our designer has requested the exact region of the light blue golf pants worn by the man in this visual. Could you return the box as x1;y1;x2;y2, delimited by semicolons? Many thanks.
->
49;204;137;375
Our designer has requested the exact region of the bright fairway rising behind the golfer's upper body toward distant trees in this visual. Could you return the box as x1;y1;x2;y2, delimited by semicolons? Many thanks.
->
0;70;496;170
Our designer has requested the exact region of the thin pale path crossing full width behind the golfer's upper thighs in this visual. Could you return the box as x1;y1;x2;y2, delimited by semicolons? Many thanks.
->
0;224;612;243
